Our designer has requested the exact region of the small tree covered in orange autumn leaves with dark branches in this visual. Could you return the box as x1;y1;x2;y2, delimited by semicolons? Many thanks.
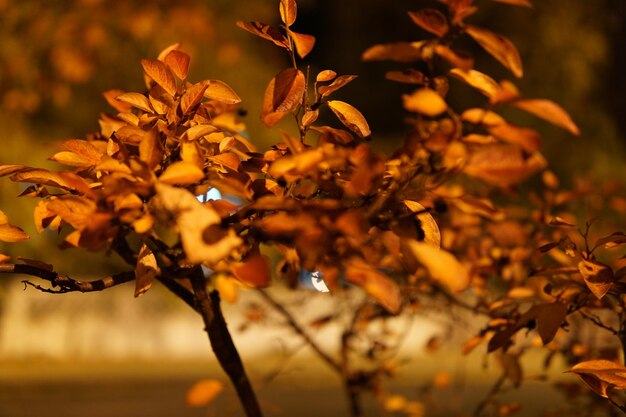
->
0;0;626;416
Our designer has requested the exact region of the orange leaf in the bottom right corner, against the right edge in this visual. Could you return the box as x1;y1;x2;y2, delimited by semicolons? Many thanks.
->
570;359;626;398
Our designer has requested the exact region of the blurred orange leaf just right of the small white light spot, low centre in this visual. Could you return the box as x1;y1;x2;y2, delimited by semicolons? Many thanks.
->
345;258;402;314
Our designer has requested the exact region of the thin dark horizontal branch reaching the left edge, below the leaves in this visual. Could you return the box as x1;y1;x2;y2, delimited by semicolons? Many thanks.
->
0;264;135;293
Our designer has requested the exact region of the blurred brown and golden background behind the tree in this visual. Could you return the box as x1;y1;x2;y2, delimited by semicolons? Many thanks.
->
0;0;626;417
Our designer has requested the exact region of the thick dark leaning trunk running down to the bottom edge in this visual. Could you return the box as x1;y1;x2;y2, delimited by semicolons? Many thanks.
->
190;268;263;417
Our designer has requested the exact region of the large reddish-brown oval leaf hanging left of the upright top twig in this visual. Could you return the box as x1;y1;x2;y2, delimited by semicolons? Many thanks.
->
261;68;306;127
